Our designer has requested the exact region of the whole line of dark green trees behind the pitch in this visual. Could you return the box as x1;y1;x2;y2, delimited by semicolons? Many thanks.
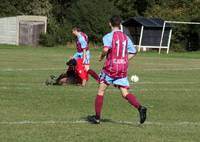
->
0;0;200;51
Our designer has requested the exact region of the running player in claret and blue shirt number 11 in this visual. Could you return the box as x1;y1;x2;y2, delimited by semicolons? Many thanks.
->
88;16;147;124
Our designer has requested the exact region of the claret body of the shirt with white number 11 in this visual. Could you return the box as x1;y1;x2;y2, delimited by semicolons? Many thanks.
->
103;31;128;78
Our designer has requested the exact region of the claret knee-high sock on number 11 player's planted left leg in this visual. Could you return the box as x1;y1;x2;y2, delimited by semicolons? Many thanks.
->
95;95;103;119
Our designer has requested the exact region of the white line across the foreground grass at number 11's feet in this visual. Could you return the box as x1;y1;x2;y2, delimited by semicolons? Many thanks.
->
0;120;200;126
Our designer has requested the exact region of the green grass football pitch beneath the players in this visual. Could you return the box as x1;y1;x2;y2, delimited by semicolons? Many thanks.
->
0;45;200;142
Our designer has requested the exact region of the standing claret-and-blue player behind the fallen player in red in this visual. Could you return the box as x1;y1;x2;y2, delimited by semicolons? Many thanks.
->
72;27;90;71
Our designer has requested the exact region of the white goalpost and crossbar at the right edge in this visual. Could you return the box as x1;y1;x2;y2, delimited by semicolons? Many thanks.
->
159;21;200;54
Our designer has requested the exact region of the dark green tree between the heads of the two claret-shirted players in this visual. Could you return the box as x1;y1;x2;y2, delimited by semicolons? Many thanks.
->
68;0;120;40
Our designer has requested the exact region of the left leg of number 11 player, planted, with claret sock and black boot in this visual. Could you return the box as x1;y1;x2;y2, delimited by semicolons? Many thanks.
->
88;83;108;124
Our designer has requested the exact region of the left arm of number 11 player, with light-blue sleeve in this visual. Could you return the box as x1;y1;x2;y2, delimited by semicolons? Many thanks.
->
99;34;112;61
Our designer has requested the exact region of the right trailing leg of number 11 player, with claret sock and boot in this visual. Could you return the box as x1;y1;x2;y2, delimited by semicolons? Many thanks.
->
120;87;147;124
